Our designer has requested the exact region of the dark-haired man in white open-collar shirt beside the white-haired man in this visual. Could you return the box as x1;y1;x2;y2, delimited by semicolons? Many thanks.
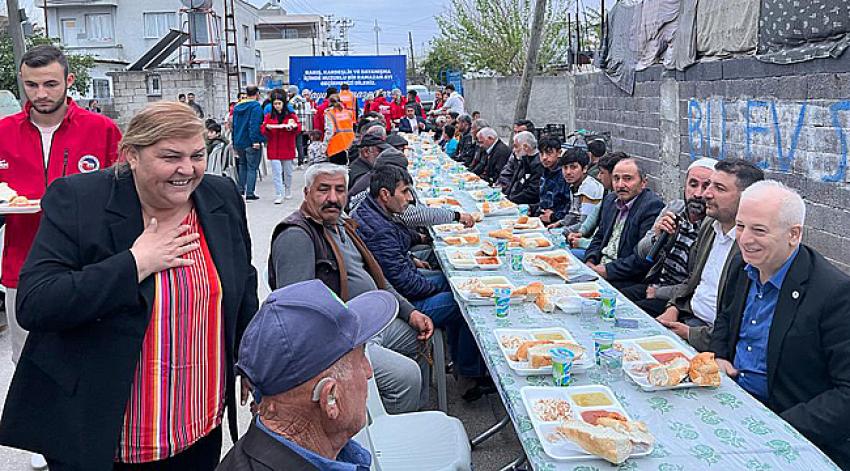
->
658;159;764;351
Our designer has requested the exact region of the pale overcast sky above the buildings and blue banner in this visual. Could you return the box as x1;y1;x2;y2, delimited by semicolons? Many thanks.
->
8;0;614;56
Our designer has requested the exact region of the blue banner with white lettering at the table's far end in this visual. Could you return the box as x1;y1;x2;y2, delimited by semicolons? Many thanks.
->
289;56;407;105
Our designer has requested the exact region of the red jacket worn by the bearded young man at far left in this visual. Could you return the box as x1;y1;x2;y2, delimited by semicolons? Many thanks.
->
0;98;121;288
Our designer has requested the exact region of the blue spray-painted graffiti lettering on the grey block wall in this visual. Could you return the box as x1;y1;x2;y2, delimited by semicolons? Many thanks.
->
687;97;850;183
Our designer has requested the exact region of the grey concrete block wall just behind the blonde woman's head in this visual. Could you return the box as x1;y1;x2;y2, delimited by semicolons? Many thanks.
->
110;69;229;129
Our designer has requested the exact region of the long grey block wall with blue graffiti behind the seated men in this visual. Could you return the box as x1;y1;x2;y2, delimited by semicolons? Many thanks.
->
464;54;850;272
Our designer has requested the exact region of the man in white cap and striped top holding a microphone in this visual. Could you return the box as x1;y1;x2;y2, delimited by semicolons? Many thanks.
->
621;157;717;316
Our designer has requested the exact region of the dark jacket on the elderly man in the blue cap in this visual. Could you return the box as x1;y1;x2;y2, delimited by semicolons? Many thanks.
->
215;419;318;471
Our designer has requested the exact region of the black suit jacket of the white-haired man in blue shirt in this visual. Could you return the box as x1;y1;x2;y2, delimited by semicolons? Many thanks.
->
711;249;850;469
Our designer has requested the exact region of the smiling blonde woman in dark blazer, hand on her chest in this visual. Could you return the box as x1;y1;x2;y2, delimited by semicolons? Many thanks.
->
0;102;258;471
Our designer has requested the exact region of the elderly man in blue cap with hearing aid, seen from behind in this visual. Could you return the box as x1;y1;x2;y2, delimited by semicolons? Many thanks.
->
217;280;398;471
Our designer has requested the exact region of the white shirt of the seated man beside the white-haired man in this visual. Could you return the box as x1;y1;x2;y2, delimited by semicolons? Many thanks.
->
691;221;735;325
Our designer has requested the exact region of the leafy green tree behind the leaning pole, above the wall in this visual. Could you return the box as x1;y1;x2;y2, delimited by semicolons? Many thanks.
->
436;0;574;75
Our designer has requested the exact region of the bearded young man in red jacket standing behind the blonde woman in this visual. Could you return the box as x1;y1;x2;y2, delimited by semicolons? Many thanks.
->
0;46;121;388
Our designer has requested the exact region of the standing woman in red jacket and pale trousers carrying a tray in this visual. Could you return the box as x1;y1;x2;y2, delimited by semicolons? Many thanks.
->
260;97;301;204
